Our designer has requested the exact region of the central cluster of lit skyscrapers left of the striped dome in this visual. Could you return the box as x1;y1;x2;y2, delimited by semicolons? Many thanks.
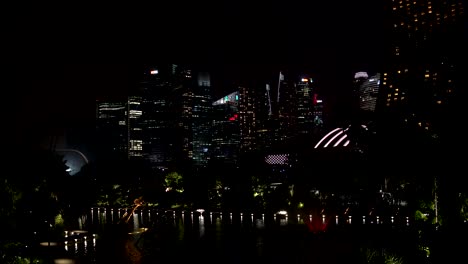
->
96;68;323;169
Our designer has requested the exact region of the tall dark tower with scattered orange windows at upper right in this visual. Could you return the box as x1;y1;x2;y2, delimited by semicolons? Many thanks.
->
381;0;466;137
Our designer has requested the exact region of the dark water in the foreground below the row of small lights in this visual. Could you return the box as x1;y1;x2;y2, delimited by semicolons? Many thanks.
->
49;208;422;264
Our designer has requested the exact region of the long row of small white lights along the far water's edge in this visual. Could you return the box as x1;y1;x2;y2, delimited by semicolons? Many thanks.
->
86;207;412;228
